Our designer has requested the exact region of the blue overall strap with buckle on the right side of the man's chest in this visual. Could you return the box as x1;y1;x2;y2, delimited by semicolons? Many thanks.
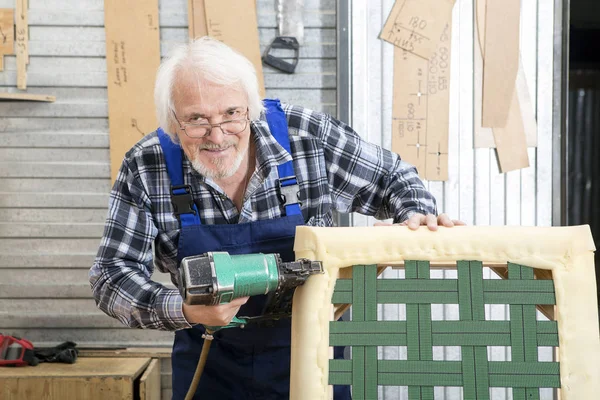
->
264;99;302;215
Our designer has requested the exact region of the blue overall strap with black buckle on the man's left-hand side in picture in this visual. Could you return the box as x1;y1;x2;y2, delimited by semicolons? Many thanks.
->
157;128;201;228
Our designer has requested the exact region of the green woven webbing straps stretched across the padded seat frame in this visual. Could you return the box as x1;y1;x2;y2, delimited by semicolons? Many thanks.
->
329;261;560;400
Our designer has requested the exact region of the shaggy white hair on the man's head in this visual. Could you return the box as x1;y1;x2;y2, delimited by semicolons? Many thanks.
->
154;36;264;139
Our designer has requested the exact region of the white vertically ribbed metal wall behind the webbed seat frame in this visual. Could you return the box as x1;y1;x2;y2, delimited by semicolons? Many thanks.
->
351;0;554;400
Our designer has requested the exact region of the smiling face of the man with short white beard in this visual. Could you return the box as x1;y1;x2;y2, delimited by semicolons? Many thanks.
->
173;79;250;181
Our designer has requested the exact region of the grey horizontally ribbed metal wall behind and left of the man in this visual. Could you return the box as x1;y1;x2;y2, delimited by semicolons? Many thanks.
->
0;0;336;396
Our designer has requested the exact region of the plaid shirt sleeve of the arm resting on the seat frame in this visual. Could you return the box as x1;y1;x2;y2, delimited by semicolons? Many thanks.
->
317;114;437;222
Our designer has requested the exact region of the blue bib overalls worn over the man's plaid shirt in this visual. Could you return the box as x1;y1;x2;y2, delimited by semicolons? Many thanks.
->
158;100;350;400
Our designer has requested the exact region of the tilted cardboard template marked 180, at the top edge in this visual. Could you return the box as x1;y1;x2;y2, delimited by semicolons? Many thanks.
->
379;0;455;59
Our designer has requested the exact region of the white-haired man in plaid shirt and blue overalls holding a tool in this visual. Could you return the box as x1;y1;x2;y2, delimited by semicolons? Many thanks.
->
90;38;461;400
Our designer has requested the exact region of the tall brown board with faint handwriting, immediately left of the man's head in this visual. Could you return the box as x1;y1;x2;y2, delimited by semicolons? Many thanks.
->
104;0;160;181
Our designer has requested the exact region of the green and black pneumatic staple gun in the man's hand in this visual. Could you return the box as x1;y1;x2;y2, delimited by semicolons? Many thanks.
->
179;252;323;331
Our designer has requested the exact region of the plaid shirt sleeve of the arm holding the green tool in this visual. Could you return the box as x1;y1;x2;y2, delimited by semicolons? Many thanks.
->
89;160;190;331
